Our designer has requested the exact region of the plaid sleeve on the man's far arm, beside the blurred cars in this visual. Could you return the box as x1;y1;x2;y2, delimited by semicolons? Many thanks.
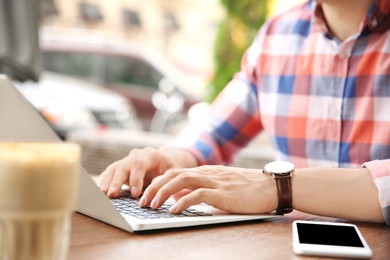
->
170;31;268;165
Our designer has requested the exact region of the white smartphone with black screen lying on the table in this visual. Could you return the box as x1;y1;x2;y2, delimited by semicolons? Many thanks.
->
292;220;372;258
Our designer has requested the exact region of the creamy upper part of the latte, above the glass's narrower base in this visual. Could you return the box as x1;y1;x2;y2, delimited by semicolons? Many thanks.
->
0;143;80;211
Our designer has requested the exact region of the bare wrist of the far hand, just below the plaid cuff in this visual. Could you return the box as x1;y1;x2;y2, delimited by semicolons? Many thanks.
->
159;146;198;168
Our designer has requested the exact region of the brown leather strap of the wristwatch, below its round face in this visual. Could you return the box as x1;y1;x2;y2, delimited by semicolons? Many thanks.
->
274;175;293;214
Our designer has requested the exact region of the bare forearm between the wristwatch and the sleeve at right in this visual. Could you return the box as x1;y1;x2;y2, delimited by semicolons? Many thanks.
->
292;168;384;222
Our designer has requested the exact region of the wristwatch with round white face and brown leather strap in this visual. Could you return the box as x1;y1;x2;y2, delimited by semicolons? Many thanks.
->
263;161;295;214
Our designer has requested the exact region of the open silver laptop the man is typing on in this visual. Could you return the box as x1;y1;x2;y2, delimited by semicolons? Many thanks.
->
0;75;280;232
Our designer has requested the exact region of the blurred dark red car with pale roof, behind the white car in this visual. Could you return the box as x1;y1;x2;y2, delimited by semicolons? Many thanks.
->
41;29;201;132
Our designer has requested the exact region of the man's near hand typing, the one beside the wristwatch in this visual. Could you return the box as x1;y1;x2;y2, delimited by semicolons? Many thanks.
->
140;166;277;214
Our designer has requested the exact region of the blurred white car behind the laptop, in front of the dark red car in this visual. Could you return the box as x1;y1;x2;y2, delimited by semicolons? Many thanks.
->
15;71;141;140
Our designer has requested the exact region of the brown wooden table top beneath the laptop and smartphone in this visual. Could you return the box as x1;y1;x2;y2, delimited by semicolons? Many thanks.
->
69;211;390;260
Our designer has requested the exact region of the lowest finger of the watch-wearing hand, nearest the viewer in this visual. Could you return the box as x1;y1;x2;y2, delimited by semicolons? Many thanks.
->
169;188;217;214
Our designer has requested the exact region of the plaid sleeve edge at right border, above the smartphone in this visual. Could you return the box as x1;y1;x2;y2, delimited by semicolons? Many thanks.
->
363;159;390;225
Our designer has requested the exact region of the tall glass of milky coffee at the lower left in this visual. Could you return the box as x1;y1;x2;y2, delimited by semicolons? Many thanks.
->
0;142;81;260
